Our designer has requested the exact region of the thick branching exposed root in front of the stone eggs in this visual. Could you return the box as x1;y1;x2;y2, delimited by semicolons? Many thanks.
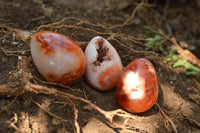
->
0;56;138;132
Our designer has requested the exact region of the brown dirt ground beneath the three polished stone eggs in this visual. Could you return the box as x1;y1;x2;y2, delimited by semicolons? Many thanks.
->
0;0;200;133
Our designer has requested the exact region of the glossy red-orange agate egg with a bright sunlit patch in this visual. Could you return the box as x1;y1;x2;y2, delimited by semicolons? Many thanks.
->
116;58;159;113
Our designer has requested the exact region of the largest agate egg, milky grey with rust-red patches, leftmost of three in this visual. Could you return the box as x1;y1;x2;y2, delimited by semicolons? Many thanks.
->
30;31;86;85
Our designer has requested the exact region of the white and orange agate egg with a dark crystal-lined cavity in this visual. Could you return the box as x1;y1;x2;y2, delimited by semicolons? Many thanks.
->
85;36;122;91
